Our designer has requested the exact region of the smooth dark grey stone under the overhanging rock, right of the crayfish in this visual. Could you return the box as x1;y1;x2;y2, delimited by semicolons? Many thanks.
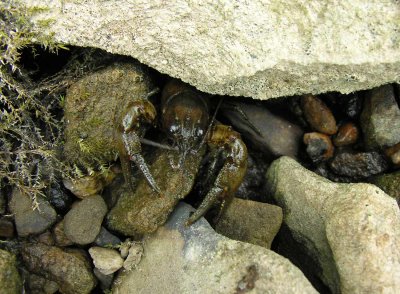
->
221;102;303;158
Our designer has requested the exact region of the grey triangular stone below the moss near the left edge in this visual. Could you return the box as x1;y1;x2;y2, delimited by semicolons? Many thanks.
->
10;189;57;237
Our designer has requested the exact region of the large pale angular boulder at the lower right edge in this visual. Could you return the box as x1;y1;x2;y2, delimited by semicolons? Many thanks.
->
267;157;400;293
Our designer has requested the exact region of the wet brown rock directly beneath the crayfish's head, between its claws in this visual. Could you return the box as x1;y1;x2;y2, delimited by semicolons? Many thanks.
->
107;150;201;236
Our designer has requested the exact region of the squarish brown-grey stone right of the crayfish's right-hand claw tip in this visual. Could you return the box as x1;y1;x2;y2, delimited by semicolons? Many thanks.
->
215;198;283;249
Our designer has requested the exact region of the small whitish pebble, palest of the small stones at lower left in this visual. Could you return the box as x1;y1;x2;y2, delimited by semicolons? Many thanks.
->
89;247;124;275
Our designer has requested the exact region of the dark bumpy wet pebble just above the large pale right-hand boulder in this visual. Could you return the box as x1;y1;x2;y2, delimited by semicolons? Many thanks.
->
329;152;388;179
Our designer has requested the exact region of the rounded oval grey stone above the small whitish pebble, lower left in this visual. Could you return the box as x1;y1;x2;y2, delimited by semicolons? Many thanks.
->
64;195;107;245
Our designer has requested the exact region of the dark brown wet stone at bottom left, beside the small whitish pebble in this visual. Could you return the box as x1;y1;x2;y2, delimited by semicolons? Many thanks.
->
21;243;96;294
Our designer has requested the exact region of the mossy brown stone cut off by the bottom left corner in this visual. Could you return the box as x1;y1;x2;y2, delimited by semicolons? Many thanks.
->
0;249;22;294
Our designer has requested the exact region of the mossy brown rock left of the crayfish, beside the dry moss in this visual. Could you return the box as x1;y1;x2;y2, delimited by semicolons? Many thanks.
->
64;62;153;167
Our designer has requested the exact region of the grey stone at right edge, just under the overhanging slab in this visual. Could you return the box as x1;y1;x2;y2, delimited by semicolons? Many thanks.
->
361;85;400;149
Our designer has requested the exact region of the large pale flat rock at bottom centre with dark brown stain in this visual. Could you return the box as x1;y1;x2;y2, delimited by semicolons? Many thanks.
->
113;204;316;294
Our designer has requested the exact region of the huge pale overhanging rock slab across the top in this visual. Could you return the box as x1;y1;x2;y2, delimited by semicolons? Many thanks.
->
24;0;400;99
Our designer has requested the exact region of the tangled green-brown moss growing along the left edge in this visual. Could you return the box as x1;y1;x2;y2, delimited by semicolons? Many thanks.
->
0;1;65;207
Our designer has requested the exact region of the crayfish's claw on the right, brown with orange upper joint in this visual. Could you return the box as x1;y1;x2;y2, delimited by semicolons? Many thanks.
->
186;124;248;225
